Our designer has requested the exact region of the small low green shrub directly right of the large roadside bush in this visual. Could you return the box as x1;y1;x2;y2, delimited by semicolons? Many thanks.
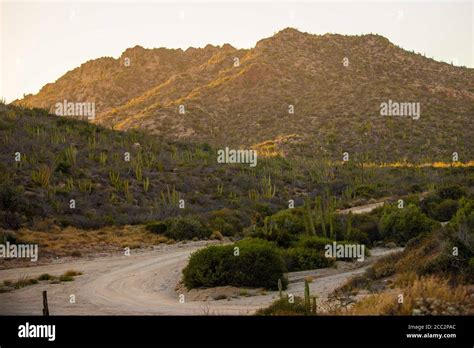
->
283;247;334;272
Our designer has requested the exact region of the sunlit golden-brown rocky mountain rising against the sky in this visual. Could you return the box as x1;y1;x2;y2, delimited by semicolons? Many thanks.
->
15;28;474;162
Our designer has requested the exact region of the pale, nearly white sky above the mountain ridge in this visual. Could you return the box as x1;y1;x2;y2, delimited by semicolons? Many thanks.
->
0;0;474;102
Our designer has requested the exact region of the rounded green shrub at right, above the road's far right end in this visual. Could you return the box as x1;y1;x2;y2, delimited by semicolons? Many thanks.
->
381;204;437;244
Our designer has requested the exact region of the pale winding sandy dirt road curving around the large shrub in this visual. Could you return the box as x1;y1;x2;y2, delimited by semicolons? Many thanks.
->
0;242;402;315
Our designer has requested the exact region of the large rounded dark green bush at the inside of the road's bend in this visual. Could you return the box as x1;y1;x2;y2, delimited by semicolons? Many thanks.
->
183;239;287;289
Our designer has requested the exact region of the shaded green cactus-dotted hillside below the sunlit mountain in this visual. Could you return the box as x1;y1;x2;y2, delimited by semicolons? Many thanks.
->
0;104;473;231
